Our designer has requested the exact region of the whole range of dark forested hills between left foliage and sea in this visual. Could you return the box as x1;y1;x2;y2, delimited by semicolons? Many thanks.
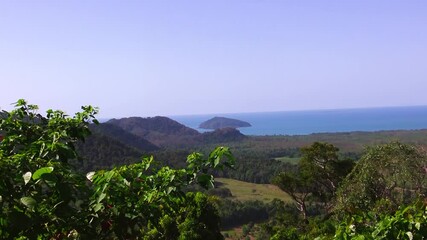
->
75;117;247;172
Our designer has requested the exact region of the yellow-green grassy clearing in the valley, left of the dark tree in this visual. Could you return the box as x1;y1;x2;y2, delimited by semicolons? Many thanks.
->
215;178;292;202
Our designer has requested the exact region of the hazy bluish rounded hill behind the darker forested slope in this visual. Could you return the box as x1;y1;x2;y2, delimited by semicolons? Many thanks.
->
107;117;201;147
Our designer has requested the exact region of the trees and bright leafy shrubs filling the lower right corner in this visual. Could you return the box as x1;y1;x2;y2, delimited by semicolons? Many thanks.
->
258;142;427;239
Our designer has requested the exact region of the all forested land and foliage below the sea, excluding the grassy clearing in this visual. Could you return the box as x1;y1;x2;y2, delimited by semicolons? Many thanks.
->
0;100;427;239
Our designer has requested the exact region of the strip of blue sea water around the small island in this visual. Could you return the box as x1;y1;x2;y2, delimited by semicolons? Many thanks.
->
170;106;427;135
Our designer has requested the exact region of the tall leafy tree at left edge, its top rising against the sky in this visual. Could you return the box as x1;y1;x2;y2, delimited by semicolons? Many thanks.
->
0;100;97;238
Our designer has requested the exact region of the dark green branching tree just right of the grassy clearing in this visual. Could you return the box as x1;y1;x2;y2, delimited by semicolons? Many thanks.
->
273;142;353;220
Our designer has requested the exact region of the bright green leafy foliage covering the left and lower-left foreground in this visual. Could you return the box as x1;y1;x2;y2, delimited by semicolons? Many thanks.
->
0;100;234;239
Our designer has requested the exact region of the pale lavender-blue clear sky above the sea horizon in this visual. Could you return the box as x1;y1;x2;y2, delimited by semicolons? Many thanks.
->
0;0;427;118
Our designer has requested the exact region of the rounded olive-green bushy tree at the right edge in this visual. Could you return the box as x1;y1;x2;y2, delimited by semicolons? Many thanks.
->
336;142;427;213
